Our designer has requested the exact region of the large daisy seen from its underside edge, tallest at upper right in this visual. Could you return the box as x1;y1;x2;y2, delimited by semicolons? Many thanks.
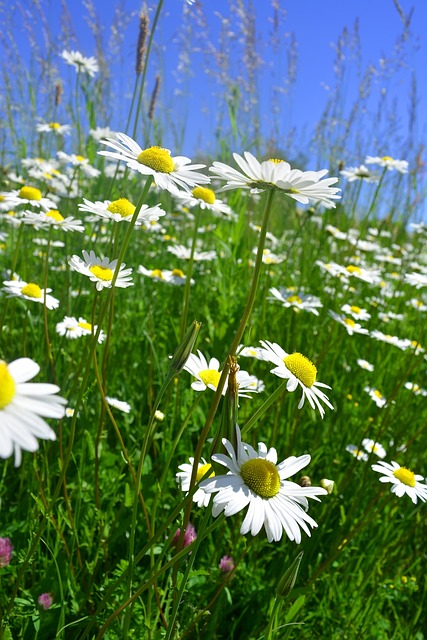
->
209;151;341;207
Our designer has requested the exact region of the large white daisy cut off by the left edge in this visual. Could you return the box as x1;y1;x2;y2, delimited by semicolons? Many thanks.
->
0;358;67;467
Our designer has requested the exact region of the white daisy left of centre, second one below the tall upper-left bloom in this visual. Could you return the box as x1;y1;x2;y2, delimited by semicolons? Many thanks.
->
68;250;133;291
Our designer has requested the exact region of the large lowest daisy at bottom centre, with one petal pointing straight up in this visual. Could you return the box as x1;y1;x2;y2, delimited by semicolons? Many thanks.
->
200;424;327;544
